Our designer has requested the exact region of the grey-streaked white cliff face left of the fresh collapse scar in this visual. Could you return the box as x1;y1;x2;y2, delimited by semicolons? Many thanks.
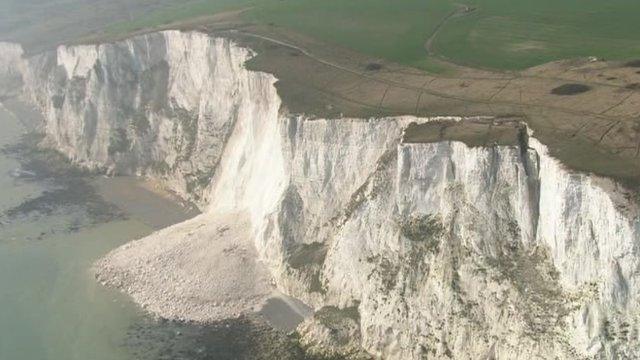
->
8;32;279;204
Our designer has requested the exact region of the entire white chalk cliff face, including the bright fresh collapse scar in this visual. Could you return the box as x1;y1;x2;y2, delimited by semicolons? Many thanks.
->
5;32;640;359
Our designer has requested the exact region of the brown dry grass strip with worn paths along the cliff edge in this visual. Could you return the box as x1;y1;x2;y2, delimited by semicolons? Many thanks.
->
219;23;640;181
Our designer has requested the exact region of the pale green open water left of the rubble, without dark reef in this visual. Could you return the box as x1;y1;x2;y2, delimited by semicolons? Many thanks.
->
0;101;152;360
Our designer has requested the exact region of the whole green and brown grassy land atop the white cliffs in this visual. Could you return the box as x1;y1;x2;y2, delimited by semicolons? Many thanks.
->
5;0;640;188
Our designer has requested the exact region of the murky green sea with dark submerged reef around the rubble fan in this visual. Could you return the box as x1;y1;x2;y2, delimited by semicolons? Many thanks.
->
0;106;312;360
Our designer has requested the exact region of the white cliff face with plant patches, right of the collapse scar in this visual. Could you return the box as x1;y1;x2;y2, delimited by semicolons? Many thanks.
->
258;119;639;359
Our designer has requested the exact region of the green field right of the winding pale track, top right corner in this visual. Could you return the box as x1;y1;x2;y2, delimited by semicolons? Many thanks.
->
434;0;640;70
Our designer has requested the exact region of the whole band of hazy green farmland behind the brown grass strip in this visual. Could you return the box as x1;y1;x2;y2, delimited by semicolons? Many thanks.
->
0;0;640;70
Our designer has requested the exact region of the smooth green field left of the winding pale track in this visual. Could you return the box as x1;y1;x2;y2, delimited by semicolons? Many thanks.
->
247;0;456;67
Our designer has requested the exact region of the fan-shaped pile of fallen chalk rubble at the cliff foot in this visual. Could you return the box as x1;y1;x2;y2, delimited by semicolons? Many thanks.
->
93;213;313;332
